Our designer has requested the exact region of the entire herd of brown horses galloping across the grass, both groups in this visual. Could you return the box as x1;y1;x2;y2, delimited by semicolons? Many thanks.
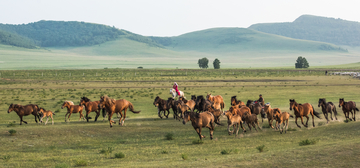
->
7;90;359;139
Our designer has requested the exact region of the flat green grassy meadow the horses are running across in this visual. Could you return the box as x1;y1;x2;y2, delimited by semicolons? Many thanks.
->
0;69;360;167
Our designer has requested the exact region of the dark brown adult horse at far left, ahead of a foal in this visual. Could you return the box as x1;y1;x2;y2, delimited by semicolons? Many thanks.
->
8;104;40;125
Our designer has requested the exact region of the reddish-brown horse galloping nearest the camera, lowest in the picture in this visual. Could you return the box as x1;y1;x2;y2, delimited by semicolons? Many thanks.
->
183;111;220;140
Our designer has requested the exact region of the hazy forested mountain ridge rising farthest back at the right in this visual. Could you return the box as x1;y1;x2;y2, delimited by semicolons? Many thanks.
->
249;15;360;46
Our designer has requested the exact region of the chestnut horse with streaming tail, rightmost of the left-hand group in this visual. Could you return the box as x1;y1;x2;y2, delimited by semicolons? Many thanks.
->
99;95;141;128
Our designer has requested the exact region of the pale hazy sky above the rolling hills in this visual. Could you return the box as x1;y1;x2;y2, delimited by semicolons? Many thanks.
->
0;0;360;36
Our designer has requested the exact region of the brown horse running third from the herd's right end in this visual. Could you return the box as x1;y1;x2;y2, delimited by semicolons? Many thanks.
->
290;99;321;128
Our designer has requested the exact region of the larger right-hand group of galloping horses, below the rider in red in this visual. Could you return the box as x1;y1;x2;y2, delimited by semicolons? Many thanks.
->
153;94;359;140
